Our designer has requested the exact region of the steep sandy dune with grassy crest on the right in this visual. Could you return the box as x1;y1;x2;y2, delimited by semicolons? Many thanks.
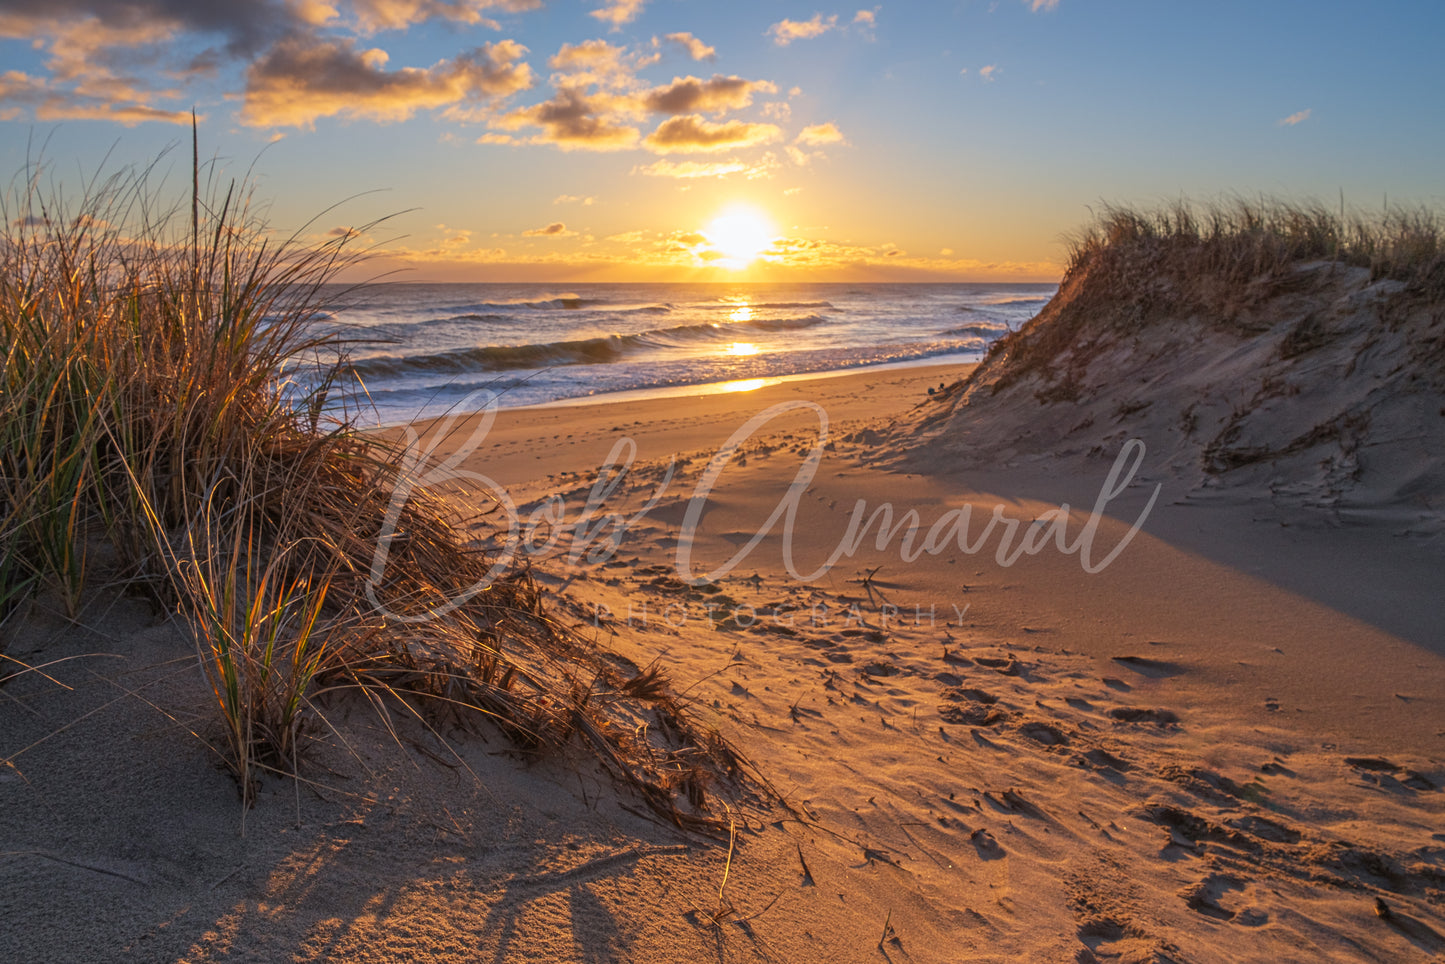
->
890;207;1445;536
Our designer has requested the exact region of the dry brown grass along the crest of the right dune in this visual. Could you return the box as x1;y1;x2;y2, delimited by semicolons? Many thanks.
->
968;198;1445;397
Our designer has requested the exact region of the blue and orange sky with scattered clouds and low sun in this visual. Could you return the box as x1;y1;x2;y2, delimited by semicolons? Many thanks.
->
0;0;1445;282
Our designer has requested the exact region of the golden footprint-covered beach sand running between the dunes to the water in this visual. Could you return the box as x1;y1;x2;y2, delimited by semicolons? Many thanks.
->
0;369;1445;963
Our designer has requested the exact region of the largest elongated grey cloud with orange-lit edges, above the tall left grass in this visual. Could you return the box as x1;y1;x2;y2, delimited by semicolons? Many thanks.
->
240;35;532;129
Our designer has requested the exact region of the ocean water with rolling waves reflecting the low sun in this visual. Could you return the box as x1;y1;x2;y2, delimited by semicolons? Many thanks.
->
316;283;1058;423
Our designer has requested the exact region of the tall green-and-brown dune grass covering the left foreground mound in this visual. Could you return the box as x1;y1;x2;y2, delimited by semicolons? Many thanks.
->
0;143;757;830
